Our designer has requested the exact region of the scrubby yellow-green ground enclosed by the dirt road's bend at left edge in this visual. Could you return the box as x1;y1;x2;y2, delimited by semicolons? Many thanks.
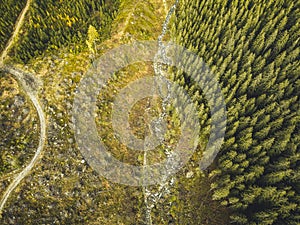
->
0;73;39;176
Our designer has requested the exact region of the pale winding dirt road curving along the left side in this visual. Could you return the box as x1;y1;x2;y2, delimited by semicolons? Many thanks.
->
0;0;46;217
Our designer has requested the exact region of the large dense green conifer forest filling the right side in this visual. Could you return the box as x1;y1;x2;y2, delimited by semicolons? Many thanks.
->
172;0;300;225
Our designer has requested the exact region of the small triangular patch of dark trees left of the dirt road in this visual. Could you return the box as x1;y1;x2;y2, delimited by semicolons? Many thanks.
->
0;0;26;52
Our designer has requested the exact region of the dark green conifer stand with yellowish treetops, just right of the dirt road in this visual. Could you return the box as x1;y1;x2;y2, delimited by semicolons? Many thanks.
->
7;0;119;63
